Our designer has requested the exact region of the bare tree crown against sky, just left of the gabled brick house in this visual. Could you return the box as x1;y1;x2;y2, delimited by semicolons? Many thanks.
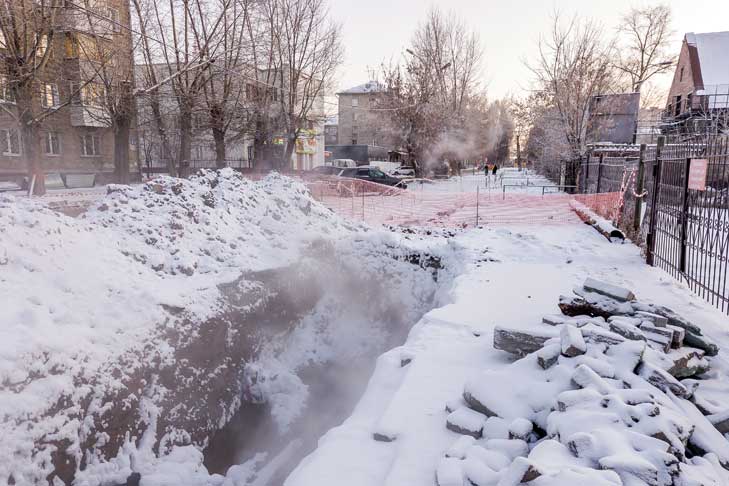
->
616;5;677;92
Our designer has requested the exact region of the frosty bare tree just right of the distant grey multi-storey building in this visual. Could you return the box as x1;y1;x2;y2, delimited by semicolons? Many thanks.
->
380;8;488;173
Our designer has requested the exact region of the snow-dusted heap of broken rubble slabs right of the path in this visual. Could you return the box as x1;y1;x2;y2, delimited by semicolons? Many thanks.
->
436;279;729;486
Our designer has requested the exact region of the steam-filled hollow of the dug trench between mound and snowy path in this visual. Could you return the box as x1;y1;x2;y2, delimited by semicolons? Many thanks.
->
204;245;446;486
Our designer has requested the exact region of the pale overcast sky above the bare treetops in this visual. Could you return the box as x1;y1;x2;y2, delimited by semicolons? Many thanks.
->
331;0;729;98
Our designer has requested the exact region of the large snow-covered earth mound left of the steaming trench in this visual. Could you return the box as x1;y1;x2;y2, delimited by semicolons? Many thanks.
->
0;170;360;483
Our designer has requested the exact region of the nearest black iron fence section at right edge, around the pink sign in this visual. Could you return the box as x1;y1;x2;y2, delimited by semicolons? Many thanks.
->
646;139;729;314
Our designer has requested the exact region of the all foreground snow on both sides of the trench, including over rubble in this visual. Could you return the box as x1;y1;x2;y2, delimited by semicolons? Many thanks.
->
5;168;729;486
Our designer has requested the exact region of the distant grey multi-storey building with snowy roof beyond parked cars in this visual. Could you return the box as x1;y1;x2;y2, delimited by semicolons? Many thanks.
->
337;81;396;150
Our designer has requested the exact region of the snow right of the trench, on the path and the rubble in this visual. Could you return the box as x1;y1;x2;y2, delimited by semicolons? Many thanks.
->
286;225;729;486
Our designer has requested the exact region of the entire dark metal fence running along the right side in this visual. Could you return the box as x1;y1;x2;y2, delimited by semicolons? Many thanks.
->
580;137;729;314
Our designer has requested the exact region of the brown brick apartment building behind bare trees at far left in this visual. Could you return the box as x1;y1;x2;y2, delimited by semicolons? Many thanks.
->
0;0;137;187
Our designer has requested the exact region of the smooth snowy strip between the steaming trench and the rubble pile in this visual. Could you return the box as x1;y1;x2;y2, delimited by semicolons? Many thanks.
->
285;225;729;486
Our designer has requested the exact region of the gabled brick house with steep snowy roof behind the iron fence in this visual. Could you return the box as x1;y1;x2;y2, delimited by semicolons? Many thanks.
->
665;32;729;132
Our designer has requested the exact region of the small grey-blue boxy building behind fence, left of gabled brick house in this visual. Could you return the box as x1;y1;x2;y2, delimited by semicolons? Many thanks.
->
587;93;640;143
